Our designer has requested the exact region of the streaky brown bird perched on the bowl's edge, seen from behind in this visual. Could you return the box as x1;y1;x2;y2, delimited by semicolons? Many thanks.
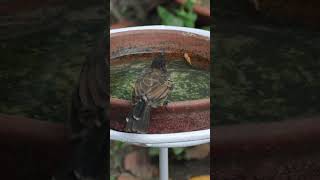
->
125;52;173;134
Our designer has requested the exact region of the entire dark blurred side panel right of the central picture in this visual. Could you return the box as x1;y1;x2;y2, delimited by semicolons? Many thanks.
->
211;0;320;180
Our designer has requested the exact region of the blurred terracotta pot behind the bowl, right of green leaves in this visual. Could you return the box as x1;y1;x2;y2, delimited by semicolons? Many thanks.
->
176;0;211;25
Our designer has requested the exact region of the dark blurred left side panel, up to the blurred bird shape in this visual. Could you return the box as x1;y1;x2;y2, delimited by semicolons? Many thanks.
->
0;0;107;180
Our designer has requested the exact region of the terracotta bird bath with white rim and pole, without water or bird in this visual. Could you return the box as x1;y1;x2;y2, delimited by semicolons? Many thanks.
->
110;26;210;180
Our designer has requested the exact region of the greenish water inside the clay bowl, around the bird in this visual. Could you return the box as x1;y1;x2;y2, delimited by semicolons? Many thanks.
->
110;60;210;102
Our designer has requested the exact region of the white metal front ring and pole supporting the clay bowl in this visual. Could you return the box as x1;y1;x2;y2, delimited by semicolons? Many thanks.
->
110;129;210;180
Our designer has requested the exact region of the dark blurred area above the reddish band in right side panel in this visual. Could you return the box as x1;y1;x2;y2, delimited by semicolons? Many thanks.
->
211;0;320;125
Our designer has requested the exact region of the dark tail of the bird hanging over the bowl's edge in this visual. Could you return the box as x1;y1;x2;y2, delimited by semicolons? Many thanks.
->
126;98;151;133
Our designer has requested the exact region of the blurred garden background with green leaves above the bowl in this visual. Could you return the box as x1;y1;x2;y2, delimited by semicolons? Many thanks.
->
110;0;211;29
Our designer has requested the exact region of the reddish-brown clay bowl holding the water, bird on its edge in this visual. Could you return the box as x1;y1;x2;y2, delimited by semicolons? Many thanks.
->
110;26;210;133
